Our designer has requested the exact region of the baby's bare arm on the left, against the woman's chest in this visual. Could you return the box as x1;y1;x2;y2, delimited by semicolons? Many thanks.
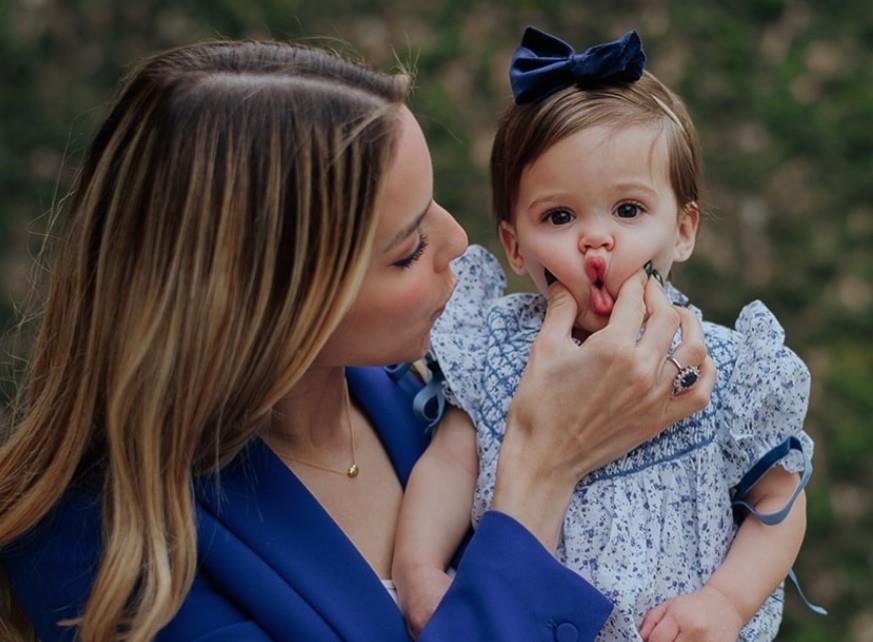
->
391;408;479;636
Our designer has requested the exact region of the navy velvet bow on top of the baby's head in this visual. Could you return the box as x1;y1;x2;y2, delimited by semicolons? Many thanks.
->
509;27;646;105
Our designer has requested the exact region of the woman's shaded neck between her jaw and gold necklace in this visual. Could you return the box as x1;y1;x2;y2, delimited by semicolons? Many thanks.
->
264;367;352;459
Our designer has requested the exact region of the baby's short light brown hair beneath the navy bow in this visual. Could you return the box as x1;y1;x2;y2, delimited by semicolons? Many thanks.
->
491;72;701;223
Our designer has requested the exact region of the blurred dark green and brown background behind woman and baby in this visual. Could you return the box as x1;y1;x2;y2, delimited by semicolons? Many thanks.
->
0;0;873;642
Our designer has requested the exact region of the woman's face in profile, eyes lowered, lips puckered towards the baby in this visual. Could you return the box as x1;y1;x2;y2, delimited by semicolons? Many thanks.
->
315;107;467;366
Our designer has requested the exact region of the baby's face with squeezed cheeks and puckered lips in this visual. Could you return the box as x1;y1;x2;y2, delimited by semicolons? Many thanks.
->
500;126;700;332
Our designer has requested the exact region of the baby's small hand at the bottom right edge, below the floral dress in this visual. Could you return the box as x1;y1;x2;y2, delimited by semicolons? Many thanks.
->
640;586;744;642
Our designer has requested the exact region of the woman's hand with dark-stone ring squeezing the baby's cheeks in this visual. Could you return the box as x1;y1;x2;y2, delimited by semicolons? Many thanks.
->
492;270;716;548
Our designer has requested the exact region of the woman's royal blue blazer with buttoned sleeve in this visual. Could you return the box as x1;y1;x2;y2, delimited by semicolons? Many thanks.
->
0;368;612;642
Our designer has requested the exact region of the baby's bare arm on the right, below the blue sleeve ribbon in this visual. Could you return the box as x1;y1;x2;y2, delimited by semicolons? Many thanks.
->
640;466;806;642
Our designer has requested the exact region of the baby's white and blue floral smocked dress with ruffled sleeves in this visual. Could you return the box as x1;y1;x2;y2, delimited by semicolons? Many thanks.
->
432;246;813;641
